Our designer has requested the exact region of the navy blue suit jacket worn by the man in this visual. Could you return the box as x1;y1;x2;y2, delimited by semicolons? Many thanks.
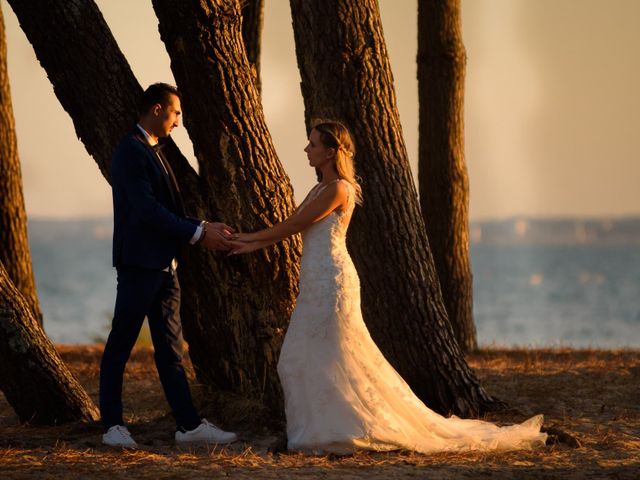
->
111;127;200;270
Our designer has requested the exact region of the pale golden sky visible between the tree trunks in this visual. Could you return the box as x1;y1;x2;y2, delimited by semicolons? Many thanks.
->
0;0;640;220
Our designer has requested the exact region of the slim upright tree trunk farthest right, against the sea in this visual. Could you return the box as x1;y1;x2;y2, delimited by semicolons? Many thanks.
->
418;0;478;351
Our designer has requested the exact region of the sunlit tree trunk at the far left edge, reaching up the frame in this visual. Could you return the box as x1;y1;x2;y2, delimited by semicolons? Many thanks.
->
0;2;42;323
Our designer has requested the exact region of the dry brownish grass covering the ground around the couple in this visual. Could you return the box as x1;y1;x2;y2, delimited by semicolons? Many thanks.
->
0;346;640;479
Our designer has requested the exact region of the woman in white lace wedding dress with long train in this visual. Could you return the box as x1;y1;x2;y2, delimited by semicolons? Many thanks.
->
231;122;546;454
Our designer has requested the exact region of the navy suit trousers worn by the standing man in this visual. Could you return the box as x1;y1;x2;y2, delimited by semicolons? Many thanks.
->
100;268;200;430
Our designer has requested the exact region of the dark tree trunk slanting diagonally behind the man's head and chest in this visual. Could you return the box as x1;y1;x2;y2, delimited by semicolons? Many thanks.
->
8;0;200;195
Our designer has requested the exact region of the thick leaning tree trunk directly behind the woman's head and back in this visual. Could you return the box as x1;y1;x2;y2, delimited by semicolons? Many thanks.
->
291;0;497;416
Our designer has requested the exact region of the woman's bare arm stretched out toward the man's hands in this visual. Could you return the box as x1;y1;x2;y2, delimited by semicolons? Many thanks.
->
234;182;348;253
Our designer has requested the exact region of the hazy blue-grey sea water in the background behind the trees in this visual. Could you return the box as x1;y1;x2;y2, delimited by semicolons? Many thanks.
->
29;219;640;348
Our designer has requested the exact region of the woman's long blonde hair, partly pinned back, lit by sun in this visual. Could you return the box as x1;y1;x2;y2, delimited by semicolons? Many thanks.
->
312;119;362;204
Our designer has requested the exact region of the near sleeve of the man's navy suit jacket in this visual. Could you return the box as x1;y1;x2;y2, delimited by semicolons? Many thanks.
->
111;143;199;242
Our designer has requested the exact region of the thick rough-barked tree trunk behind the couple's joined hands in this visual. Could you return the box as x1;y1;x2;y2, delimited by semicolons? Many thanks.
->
153;0;298;411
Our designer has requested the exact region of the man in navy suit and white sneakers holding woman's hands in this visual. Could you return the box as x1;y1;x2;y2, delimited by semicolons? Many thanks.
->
100;83;237;448
